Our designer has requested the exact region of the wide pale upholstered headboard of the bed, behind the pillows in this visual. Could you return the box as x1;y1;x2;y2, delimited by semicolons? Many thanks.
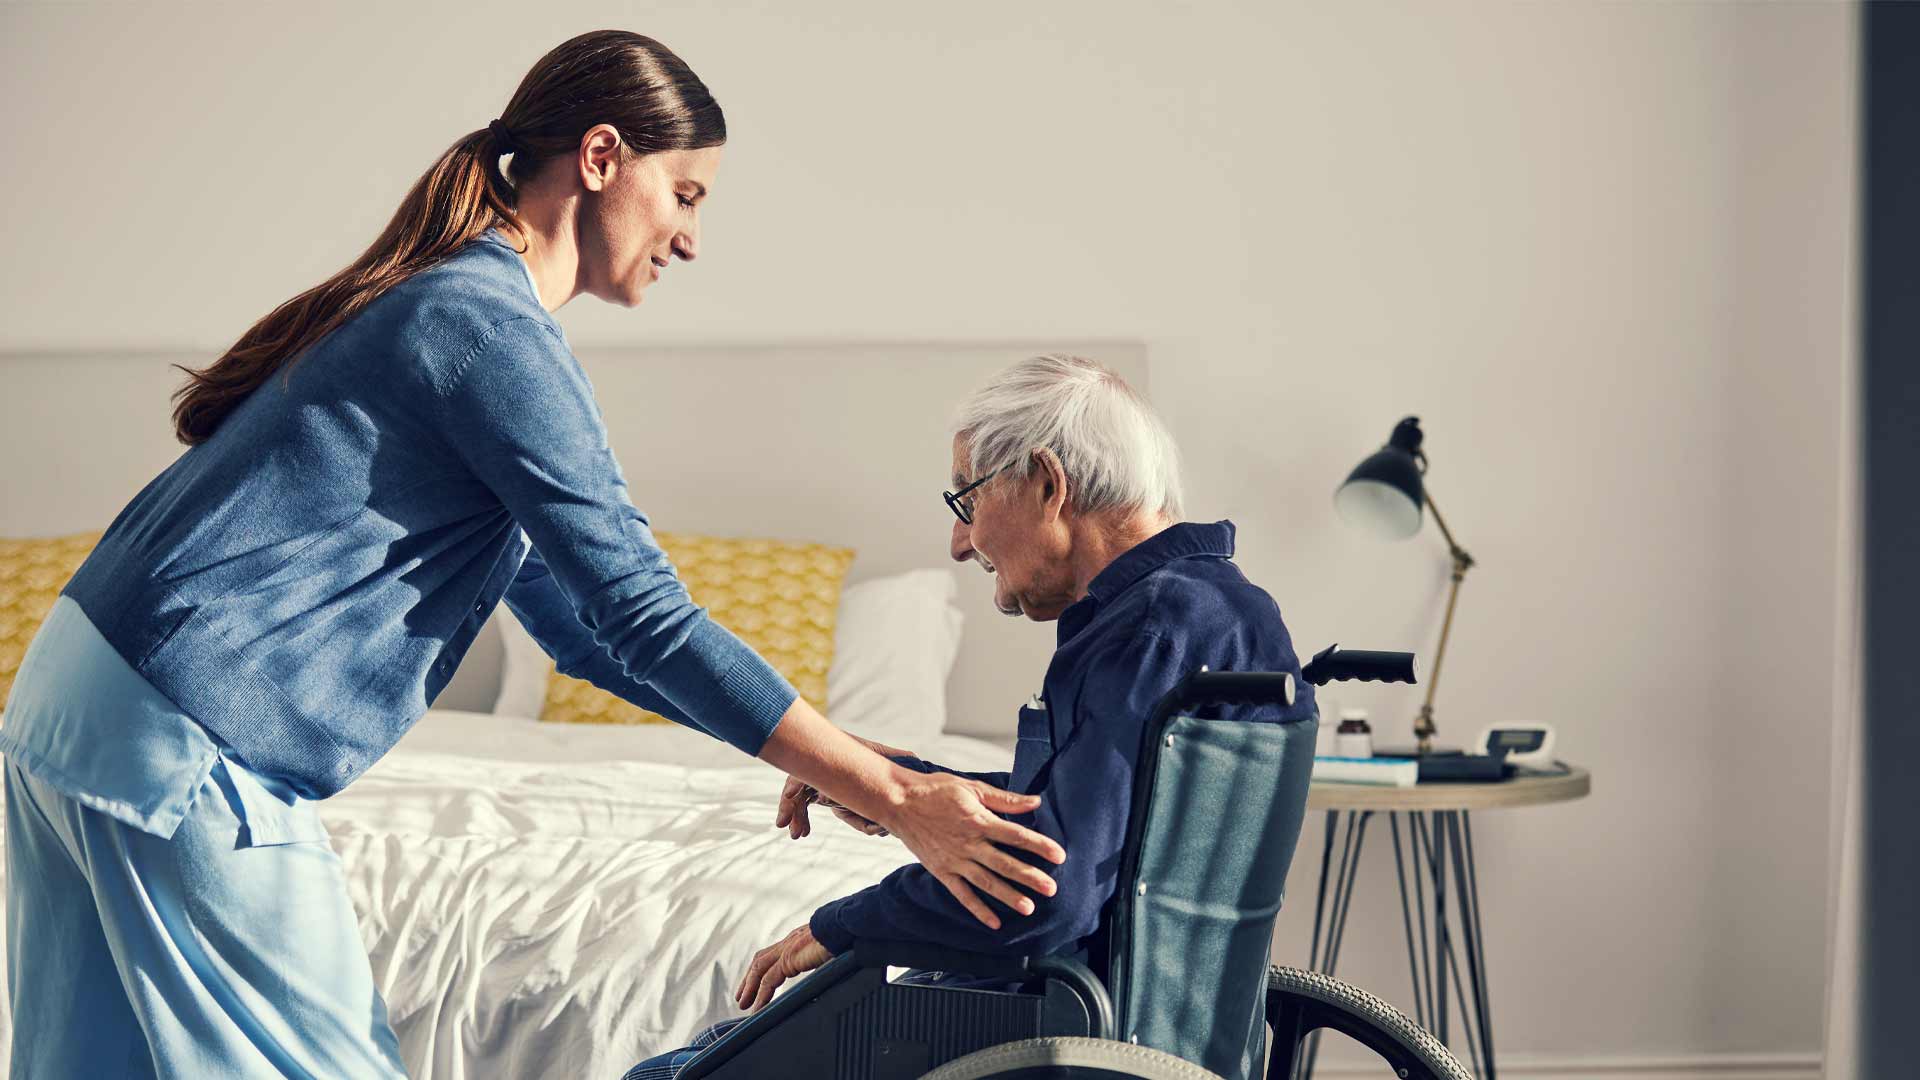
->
0;342;1146;736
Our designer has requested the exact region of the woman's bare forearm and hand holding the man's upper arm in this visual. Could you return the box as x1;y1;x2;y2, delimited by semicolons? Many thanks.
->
760;698;1068;930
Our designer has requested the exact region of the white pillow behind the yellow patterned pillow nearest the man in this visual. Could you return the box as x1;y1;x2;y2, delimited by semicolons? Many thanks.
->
493;569;962;744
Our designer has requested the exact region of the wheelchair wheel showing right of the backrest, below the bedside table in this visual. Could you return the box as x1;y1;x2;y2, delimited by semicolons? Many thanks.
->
1267;967;1473;1080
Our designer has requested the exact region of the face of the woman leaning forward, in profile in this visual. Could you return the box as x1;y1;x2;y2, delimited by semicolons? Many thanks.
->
580;141;720;307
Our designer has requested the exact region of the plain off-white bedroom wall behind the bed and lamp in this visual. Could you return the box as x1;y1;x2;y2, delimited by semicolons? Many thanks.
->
0;2;1853;1063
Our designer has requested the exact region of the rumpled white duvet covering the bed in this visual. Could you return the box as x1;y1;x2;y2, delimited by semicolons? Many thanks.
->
0;711;1012;1080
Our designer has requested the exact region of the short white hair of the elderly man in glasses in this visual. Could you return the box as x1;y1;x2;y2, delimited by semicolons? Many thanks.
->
952;354;1181;517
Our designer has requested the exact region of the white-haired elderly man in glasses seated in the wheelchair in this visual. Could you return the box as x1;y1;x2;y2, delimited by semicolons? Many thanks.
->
628;356;1313;1080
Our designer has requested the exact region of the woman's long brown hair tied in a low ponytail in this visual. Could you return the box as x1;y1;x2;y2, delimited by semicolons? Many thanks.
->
173;31;726;446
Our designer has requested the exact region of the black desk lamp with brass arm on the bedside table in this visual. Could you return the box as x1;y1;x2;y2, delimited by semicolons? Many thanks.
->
1332;417;1473;755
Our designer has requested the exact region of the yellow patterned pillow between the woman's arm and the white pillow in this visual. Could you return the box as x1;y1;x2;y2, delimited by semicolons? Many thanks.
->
540;532;852;724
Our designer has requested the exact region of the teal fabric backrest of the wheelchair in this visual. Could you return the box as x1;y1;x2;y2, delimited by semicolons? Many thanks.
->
1106;673;1319;1080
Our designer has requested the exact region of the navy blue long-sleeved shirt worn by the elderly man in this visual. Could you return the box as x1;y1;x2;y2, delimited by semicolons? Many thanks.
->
810;521;1313;957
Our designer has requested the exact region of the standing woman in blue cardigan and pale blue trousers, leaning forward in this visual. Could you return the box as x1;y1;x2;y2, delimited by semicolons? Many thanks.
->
0;31;1066;1076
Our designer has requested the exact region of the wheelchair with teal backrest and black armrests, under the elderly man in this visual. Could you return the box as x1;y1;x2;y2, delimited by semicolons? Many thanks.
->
680;646;1469;1080
